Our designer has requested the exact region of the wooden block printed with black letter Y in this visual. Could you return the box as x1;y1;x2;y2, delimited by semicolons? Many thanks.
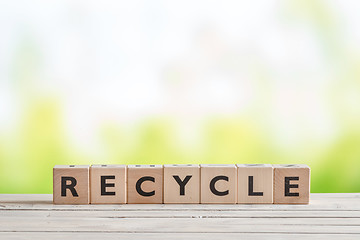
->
164;164;200;203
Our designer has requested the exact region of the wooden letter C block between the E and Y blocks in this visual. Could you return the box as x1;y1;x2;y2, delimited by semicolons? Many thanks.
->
127;165;163;203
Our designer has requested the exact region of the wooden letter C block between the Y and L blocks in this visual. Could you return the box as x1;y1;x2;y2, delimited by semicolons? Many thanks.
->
200;164;237;204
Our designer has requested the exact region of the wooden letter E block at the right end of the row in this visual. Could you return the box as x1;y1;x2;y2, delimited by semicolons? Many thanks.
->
273;164;310;204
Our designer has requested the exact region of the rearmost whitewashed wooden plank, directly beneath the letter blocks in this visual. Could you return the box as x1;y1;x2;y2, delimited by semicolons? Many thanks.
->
0;193;360;211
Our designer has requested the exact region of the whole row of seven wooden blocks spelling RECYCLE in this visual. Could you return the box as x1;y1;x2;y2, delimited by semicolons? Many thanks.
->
53;164;310;204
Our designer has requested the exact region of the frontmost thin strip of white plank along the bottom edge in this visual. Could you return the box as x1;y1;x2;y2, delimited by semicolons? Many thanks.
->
0;232;360;240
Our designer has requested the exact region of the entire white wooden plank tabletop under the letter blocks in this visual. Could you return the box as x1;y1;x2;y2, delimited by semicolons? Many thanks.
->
0;193;360;240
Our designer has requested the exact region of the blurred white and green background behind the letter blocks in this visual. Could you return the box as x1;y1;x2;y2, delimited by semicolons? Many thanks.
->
0;0;360;193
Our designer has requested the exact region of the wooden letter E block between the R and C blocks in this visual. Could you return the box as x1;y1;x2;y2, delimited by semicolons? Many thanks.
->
90;165;127;204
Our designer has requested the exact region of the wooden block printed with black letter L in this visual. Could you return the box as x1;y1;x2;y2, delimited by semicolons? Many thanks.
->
236;164;274;203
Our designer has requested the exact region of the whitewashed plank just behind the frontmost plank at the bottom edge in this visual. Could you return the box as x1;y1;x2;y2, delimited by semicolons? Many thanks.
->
0;217;360;234
